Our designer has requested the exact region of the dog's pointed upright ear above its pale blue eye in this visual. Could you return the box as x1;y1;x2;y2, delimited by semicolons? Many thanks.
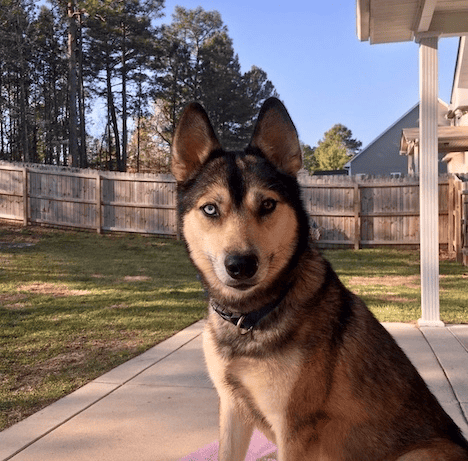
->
171;102;221;182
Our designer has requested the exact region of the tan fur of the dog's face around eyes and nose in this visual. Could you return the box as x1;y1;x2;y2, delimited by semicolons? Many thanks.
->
183;185;297;299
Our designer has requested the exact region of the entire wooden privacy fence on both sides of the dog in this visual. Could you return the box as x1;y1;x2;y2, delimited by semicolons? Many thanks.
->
0;163;468;259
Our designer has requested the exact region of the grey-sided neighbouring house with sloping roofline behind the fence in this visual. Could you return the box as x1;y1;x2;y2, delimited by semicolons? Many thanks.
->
345;99;449;177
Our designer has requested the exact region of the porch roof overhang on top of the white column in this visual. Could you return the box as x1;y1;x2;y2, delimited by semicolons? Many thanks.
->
356;0;468;43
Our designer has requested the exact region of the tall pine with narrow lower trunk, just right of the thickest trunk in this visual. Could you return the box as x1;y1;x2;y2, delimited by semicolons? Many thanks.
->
84;0;163;171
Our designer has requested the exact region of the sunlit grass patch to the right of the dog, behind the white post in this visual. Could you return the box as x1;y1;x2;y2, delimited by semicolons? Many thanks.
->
324;249;468;323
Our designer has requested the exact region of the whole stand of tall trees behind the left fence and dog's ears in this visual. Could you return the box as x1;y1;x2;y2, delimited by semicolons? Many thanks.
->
0;0;277;171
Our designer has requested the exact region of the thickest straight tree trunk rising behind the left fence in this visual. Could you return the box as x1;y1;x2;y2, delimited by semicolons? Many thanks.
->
67;1;80;167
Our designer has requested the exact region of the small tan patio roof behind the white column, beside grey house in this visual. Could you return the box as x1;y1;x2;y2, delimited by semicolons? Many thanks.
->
400;126;468;155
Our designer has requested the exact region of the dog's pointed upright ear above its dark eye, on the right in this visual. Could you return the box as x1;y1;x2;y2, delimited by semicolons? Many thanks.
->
250;98;302;175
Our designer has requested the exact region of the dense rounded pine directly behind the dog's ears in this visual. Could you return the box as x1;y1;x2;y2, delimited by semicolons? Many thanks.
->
157;7;277;149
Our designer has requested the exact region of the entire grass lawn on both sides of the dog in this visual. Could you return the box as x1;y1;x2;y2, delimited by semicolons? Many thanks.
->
0;225;468;430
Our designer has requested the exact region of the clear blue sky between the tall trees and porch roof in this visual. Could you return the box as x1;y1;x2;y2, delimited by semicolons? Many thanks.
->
157;0;458;146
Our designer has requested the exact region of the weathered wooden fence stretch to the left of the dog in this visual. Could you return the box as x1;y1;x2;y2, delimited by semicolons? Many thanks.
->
0;164;177;236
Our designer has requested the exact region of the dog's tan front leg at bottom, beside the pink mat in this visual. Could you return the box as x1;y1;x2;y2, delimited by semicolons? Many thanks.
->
219;399;253;461
